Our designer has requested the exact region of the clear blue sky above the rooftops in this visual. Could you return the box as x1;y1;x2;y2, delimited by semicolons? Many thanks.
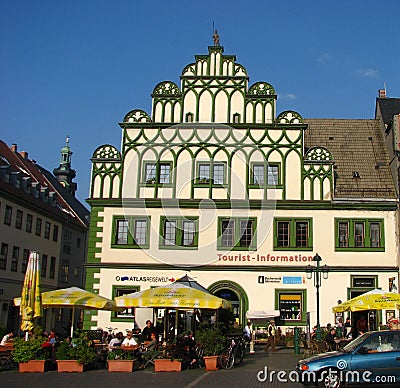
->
0;0;400;205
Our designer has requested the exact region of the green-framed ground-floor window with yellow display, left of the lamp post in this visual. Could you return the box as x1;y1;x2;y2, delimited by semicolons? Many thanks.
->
275;289;307;326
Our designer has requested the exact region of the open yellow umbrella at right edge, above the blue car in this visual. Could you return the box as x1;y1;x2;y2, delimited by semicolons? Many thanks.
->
332;289;400;313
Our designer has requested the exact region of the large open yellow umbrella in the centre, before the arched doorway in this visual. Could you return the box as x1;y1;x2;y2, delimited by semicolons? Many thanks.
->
114;283;231;309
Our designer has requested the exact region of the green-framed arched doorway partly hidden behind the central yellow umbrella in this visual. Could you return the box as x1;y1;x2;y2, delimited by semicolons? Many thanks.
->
208;280;249;325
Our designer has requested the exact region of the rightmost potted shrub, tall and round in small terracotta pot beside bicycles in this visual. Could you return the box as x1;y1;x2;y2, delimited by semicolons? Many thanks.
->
195;327;226;370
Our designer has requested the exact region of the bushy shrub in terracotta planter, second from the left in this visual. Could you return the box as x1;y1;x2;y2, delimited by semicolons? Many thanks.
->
56;334;97;372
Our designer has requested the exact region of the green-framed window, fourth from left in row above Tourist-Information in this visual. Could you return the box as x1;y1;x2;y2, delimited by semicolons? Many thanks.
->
274;218;313;250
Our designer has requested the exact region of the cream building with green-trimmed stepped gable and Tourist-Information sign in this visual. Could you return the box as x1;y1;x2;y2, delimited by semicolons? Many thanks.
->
85;46;398;329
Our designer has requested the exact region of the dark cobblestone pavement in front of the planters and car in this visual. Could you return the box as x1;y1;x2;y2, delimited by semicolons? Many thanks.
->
0;350;302;388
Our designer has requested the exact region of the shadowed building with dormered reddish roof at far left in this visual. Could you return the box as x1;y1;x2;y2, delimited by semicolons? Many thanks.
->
0;141;90;334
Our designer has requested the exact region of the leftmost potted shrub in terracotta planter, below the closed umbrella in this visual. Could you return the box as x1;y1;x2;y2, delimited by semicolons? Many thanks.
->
12;336;52;372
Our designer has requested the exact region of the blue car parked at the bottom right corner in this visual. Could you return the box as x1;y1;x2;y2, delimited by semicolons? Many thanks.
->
297;330;400;388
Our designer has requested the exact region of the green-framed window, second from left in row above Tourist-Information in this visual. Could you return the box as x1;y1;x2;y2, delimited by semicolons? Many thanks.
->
160;217;198;248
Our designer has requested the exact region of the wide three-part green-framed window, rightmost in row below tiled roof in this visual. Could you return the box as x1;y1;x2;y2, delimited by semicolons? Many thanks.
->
335;218;385;252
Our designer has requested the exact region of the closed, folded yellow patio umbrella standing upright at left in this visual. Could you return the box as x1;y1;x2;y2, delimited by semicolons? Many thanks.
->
20;252;42;331
